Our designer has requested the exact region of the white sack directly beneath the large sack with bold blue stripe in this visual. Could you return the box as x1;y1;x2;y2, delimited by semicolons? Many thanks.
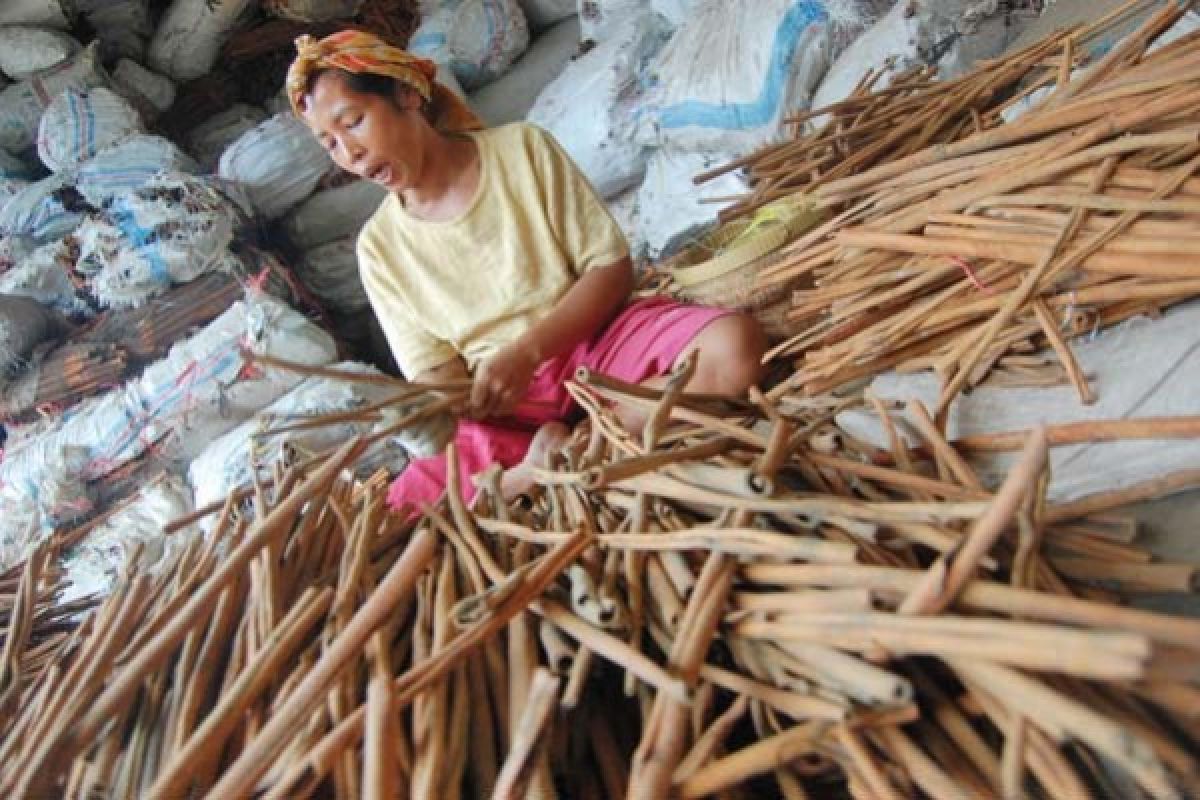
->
637;148;749;259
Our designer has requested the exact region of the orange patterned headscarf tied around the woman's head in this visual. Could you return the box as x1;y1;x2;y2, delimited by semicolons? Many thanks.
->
287;30;484;133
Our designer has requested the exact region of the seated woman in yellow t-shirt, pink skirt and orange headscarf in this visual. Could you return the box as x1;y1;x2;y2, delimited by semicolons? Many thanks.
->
287;31;764;507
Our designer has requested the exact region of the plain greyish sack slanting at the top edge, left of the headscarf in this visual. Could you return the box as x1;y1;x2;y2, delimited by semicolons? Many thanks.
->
146;0;254;83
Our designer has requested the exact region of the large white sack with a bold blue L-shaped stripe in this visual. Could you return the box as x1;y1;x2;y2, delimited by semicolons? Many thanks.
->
638;0;832;152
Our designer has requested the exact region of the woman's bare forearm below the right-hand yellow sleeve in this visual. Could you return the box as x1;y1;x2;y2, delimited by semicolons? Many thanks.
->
517;257;634;362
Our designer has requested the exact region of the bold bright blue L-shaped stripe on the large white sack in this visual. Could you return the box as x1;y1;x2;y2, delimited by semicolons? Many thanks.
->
659;0;829;131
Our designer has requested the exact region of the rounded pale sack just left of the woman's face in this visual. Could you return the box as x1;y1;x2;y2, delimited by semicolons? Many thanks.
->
217;113;334;219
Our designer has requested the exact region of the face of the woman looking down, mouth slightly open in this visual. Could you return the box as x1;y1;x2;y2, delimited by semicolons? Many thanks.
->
302;72;428;192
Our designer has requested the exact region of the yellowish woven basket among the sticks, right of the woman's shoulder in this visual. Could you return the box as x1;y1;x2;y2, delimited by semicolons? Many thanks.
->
660;198;823;338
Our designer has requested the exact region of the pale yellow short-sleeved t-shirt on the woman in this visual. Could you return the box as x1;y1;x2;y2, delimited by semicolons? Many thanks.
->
358;122;629;378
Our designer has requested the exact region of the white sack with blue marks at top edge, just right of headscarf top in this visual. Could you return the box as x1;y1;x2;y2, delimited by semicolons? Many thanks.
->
408;0;529;90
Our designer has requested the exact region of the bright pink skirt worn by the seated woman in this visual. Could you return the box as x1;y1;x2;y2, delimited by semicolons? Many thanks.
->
388;296;733;510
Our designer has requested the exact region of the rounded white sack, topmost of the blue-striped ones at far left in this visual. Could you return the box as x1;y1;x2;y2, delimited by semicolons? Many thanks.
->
37;86;143;173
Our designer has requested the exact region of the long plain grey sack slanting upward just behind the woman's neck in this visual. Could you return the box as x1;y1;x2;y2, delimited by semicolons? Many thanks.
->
470;16;580;126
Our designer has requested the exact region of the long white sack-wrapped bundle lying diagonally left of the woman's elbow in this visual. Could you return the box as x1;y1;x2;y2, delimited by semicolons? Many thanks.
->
0;295;336;569
